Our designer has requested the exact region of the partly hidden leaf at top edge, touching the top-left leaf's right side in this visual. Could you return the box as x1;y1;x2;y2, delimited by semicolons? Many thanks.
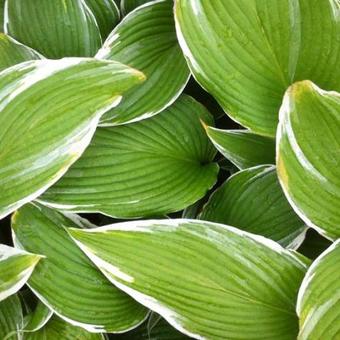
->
85;0;120;39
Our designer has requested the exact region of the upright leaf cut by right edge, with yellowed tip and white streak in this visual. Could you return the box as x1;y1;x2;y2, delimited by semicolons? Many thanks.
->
277;81;340;239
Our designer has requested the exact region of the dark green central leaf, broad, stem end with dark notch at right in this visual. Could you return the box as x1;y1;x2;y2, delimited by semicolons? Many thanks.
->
39;95;218;218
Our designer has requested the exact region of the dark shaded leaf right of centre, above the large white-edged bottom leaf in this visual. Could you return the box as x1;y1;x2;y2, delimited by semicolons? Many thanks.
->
200;166;306;248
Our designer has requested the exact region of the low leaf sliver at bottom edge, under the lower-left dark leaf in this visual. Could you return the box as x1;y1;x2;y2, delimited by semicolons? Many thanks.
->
25;316;104;340
